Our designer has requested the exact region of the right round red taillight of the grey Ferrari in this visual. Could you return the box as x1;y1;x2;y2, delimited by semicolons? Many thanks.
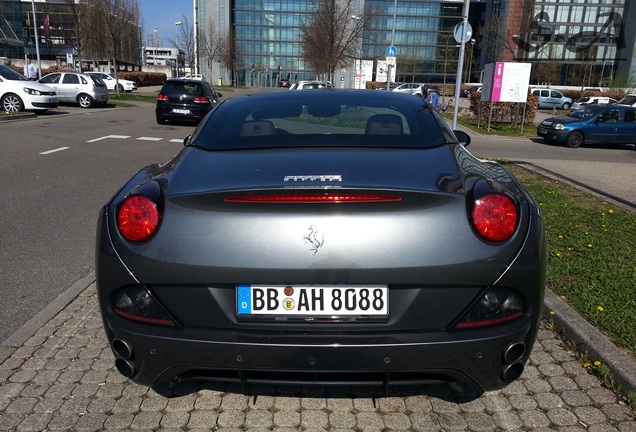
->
472;193;519;241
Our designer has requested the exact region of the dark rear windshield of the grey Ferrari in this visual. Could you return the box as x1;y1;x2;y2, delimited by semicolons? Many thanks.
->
193;91;456;149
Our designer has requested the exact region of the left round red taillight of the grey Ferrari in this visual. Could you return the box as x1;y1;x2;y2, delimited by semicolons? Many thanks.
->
117;195;159;241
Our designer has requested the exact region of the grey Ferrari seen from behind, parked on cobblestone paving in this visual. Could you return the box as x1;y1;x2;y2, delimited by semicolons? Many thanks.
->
96;90;546;393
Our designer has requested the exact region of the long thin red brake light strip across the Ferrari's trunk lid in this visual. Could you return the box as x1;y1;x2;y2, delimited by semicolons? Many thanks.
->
225;194;402;203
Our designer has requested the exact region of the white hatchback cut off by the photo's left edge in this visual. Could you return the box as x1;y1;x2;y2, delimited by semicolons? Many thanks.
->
0;65;58;112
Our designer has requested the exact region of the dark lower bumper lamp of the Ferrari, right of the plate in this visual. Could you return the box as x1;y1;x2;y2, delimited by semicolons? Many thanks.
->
456;287;525;329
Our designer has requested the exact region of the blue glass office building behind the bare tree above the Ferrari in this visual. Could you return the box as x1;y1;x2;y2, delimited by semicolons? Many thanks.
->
195;0;485;87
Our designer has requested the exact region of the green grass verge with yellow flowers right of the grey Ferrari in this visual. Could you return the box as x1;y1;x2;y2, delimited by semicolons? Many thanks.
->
507;165;636;358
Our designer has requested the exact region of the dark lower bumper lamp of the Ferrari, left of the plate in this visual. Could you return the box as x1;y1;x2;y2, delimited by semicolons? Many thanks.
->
113;286;176;327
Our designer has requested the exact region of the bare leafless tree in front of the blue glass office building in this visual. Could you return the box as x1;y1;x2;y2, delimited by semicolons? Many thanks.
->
300;0;374;79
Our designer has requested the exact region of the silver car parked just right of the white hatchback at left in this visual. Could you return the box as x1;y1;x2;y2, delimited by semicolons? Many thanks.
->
39;72;108;108
